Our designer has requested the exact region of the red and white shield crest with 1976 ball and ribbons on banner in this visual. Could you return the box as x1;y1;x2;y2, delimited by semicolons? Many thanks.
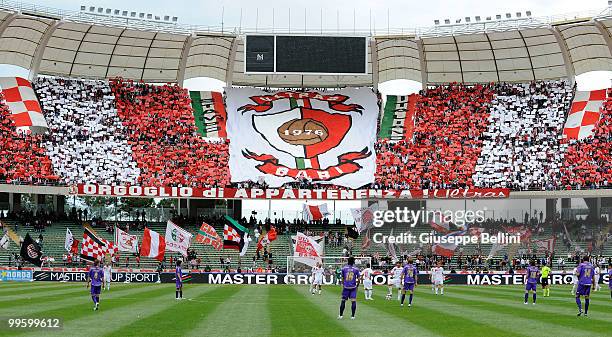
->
238;92;372;181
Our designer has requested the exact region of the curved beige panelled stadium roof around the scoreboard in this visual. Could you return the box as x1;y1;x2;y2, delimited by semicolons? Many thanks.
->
0;1;612;87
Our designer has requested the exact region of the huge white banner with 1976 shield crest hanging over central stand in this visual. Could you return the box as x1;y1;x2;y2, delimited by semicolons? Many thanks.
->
226;88;379;189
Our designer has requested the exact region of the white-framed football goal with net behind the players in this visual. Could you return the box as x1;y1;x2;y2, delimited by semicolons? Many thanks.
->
287;256;372;275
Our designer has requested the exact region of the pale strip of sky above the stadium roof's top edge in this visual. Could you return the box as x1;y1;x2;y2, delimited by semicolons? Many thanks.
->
29;0;607;33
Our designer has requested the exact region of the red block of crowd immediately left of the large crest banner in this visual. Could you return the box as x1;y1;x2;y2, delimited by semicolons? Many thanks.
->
110;78;229;187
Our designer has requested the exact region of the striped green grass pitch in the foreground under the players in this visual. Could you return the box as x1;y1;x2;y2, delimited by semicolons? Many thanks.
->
0;282;612;337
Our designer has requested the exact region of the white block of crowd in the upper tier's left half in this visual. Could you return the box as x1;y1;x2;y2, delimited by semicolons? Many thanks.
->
35;77;140;184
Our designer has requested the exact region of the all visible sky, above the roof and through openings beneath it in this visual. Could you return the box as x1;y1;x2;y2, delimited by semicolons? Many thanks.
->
0;0;612;94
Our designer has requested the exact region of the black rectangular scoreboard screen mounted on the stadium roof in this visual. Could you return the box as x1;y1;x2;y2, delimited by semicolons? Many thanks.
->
245;35;367;75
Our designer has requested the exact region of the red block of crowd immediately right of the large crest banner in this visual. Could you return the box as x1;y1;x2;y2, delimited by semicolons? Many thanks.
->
375;83;495;189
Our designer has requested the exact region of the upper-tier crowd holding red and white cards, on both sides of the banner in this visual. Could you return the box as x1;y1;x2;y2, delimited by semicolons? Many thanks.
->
0;77;612;190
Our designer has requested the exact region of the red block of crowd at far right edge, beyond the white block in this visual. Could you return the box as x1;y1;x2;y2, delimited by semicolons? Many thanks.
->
561;89;612;189
